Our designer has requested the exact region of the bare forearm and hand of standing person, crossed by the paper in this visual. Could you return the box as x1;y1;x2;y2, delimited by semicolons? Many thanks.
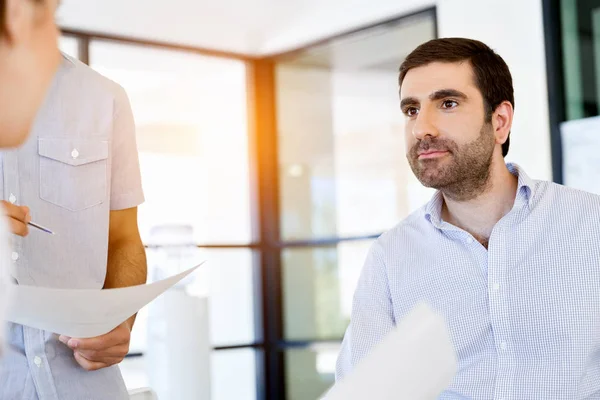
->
60;208;147;371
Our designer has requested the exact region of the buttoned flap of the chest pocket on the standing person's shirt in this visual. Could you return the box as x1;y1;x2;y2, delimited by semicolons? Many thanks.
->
38;138;108;166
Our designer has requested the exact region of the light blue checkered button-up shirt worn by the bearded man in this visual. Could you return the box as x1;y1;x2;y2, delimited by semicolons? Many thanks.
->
336;164;600;400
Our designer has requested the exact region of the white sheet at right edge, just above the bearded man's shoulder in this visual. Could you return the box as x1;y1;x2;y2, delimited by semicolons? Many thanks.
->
560;117;600;194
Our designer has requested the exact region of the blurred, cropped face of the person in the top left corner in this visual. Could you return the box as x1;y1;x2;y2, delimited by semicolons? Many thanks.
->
0;0;61;147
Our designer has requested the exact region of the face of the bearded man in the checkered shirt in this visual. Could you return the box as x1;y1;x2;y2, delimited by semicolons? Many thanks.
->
400;62;496;197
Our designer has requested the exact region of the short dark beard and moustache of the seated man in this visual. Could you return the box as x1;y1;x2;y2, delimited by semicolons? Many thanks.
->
406;123;495;201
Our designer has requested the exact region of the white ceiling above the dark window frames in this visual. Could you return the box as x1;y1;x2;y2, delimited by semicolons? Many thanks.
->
57;0;436;56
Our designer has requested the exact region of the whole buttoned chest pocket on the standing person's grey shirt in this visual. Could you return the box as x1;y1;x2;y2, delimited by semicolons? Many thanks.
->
38;138;109;211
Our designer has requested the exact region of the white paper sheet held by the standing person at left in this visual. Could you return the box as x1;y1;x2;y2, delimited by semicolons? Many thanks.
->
6;264;201;339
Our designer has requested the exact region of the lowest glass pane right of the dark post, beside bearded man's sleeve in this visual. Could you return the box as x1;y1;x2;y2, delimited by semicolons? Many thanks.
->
285;345;339;400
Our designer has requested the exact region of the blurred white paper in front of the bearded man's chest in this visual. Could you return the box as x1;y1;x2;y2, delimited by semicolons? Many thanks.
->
323;304;457;400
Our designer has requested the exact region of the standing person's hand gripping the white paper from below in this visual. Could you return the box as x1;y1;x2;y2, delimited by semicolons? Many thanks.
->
59;321;131;371
